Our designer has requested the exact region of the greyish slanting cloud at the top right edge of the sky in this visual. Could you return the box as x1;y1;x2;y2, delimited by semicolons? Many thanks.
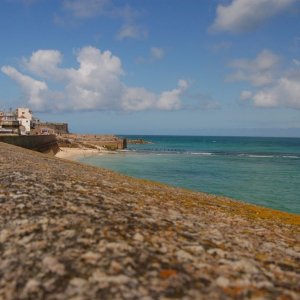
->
211;0;298;33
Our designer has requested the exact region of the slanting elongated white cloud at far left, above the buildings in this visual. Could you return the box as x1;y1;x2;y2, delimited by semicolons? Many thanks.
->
1;66;48;109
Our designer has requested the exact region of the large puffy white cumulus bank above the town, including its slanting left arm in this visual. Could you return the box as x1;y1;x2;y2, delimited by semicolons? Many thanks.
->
2;47;188;111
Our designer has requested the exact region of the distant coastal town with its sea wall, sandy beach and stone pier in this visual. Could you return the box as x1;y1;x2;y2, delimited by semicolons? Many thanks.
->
0;107;127;157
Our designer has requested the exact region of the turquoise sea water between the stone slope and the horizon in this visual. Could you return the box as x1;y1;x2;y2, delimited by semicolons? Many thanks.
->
81;136;300;214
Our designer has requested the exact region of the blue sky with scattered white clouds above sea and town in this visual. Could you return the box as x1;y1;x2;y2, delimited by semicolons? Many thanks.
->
0;0;300;137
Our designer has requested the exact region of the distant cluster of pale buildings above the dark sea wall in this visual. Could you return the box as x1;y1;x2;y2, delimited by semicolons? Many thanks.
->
0;107;69;135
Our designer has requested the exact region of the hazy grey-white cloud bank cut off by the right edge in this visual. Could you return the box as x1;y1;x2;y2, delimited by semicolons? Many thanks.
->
229;50;300;109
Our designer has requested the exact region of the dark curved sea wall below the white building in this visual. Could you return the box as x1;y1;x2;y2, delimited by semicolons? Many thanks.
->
0;135;59;154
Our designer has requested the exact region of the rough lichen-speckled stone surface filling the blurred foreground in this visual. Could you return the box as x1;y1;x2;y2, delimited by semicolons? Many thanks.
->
0;143;300;300
